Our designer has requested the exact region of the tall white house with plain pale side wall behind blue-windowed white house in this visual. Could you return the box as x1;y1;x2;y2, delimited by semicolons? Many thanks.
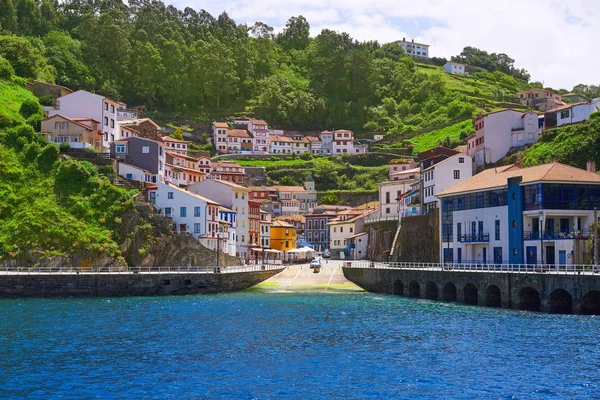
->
189;179;250;259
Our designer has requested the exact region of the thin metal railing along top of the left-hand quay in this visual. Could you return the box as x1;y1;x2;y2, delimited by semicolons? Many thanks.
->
0;264;284;275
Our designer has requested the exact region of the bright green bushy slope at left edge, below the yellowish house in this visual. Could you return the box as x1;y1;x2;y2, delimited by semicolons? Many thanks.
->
0;81;139;266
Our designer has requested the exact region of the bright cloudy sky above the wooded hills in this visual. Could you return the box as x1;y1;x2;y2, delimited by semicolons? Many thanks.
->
165;0;600;90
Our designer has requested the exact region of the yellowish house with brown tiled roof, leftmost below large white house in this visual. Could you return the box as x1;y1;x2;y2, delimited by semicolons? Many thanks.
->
40;114;102;151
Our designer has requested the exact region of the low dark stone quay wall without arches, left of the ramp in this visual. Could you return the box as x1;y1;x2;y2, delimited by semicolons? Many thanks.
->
0;269;283;297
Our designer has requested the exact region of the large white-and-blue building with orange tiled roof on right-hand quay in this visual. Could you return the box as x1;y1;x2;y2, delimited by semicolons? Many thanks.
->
438;163;600;267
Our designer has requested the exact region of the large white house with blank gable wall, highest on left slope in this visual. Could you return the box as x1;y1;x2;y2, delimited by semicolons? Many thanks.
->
48;90;123;151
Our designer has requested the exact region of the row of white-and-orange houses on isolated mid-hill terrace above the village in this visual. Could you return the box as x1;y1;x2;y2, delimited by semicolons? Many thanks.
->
212;118;367;155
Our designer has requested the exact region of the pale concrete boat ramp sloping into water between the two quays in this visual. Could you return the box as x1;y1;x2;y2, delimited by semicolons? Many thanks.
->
250;261;363;292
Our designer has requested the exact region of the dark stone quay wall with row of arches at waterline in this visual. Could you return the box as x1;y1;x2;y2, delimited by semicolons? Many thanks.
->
343;267;600;315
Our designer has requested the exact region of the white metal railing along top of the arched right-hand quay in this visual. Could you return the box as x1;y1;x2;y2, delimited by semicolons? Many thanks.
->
344;261;600;277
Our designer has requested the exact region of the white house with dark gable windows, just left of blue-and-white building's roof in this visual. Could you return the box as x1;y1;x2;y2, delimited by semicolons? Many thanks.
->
421;154;473;213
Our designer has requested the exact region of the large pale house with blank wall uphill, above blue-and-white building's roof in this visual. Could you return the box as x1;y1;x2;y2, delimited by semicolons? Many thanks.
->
467;110;540;168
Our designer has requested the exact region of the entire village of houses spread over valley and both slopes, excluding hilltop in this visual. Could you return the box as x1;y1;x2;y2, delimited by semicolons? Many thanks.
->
32;83;600;265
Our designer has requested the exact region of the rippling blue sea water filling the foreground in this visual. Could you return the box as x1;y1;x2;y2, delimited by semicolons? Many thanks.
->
0;292;600;399
